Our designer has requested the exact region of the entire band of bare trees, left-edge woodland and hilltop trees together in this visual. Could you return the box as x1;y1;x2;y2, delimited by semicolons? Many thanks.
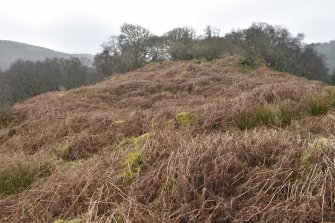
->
0;23;335;116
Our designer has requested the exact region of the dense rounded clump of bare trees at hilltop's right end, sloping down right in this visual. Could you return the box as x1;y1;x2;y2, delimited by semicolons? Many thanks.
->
224;23;329;82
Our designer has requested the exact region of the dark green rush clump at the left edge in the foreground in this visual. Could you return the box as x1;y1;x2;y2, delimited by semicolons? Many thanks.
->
0;165;37;196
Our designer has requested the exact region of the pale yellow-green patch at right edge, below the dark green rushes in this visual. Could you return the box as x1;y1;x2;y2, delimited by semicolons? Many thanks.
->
301;137;330;164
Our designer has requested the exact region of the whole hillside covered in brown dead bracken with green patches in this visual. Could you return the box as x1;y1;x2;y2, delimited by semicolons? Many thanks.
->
0;58;335;223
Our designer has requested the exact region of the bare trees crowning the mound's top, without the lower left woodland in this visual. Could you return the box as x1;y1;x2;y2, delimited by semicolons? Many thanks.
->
94;23;331;83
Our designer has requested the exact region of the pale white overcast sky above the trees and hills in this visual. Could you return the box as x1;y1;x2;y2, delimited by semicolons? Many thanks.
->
0;0;335;54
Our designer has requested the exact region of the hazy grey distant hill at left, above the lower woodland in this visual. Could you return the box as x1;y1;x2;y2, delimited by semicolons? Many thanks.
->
0;40;94;70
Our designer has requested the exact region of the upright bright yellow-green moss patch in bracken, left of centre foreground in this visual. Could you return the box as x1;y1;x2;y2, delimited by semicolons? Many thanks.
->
120;149;144;184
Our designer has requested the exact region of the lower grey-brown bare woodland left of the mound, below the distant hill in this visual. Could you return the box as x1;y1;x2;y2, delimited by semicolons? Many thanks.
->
0;58;103;117
